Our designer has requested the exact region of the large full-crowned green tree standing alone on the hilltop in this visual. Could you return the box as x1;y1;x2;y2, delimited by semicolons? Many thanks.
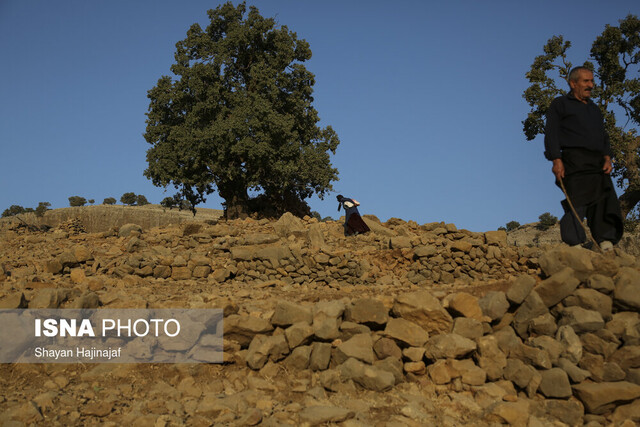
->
144;2;339;218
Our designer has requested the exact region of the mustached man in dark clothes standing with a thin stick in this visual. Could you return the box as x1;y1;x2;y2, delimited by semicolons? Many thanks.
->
544;67;623;251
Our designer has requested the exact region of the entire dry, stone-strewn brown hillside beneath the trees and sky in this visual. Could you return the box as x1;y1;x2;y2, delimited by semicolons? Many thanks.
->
0;214;640;426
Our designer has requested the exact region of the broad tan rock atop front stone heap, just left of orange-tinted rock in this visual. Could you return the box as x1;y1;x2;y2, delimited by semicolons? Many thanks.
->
392;291;453;334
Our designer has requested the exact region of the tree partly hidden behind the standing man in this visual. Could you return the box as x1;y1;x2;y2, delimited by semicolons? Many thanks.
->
523;15;640;216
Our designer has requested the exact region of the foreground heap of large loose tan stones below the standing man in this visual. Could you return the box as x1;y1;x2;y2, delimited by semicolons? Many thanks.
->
232;247;640;425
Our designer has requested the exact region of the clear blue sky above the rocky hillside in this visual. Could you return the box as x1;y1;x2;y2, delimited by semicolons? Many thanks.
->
0;0;640;231
